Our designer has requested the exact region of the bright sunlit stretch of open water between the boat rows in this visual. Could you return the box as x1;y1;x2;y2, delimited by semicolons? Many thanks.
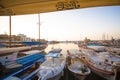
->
45;43;79;56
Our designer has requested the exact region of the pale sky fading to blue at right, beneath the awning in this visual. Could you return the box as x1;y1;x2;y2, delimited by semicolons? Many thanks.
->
0;6;120;41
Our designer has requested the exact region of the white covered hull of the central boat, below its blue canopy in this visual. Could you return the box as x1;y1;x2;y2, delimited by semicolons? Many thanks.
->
38;58;65;80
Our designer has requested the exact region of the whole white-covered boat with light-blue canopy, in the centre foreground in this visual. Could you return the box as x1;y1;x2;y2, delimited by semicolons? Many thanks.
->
38;49;65;80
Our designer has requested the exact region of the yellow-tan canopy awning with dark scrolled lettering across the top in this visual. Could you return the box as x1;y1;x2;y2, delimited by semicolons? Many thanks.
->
0;0;120;16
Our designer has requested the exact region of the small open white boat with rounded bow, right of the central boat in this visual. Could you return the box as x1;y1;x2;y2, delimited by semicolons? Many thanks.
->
66;50;91;80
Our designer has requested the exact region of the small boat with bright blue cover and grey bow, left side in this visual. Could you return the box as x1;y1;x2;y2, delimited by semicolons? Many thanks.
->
4;51;45;73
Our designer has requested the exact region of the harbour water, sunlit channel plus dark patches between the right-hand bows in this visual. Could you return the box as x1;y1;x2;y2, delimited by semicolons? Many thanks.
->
45;43;120;80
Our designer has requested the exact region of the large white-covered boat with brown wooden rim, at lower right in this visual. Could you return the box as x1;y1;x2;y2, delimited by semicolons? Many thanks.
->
81;50;117;80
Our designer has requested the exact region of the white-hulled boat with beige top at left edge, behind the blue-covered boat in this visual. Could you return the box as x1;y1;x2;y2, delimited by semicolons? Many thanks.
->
0;46;31;65
